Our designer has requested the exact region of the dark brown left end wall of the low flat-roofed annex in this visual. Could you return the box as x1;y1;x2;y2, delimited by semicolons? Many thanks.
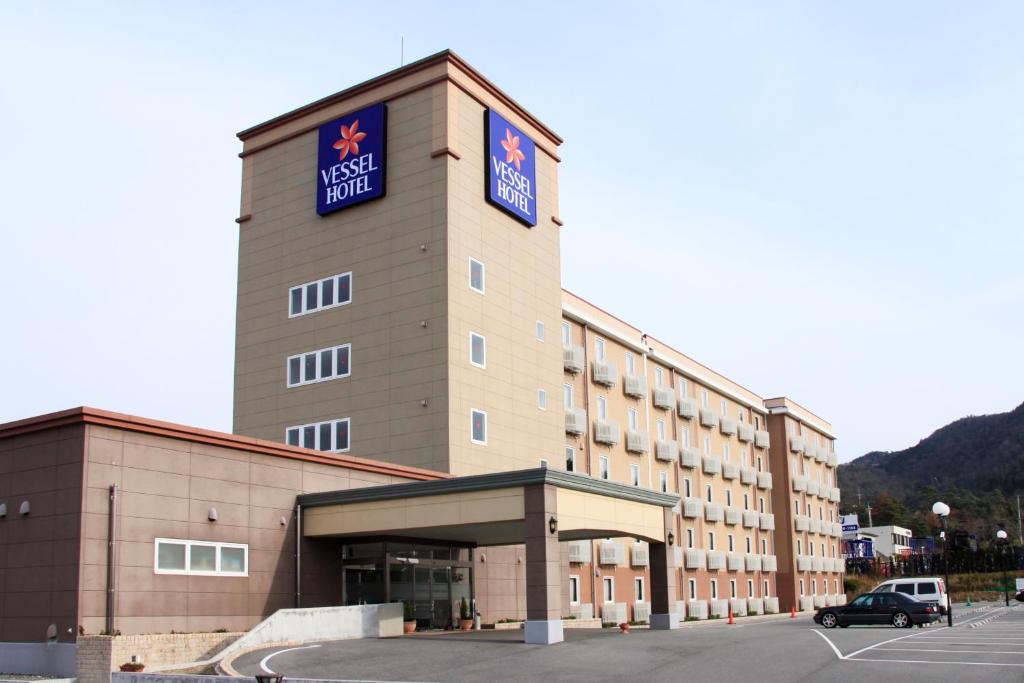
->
0;426;83;643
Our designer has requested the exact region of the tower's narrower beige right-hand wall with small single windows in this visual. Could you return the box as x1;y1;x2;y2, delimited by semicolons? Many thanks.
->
447;86;563;474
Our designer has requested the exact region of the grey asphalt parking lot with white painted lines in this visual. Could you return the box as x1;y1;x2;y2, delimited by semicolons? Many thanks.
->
234;604;1024;683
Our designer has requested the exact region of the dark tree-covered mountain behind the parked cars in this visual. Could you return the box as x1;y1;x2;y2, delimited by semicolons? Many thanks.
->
839;403;1024;541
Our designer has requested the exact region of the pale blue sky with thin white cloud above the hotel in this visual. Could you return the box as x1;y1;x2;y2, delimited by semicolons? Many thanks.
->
0;1;1024;461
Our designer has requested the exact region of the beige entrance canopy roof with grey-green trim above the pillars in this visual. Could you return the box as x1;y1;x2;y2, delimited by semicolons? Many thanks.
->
298;468;679;546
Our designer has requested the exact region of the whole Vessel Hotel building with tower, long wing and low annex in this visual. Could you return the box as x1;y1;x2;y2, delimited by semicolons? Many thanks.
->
0;52;844;663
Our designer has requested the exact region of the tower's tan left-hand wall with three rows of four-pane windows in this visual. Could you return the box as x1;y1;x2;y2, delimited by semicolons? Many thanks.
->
234;83;456;471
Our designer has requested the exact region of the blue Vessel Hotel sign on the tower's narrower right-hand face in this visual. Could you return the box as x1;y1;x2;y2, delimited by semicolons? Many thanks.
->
483;110;537;227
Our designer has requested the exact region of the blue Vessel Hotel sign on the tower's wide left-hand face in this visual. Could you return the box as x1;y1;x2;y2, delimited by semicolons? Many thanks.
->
316;102;387;216
